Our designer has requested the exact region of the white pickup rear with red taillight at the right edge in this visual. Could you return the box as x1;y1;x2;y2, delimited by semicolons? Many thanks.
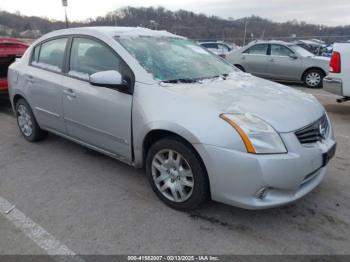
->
323;43;350;103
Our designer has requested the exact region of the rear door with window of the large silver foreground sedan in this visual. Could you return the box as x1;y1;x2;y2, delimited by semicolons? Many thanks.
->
24;37;68;133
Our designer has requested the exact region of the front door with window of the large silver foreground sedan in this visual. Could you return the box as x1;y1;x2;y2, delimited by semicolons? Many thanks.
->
63;37;134;161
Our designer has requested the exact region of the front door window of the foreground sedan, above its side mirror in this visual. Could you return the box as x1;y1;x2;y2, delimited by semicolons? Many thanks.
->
68;38;132;80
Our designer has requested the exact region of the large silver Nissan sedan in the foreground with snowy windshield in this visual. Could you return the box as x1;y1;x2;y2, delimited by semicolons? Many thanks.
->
9;27;336;210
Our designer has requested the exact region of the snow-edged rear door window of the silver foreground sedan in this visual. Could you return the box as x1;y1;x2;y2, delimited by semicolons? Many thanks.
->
32;38;68;72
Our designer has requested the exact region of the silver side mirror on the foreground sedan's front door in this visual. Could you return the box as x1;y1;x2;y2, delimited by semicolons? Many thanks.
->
90;70;129;92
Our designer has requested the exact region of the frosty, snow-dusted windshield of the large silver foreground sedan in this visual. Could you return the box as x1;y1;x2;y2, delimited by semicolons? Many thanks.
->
117;37;236;82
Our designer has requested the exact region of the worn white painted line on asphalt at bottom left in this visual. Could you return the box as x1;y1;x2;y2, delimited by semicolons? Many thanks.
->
0;196;84;262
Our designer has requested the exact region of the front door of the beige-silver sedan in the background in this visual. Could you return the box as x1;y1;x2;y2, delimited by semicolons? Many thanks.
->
268;44;302;81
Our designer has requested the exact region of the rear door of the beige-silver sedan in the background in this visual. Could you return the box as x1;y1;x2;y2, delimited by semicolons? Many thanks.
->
240;44;269;77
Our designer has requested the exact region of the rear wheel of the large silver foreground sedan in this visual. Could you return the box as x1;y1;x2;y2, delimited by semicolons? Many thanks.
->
16;99;47;142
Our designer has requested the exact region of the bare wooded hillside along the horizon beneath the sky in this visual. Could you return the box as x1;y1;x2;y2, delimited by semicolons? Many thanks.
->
0;7;350;44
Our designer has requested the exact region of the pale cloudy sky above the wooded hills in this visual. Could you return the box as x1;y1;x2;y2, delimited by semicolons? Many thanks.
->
0;0;350;26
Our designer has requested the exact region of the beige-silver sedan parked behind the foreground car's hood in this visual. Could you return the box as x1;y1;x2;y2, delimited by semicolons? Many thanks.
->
227;41;329;88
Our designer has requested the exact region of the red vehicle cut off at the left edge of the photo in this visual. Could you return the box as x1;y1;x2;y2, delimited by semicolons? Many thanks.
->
0;37;29;95
